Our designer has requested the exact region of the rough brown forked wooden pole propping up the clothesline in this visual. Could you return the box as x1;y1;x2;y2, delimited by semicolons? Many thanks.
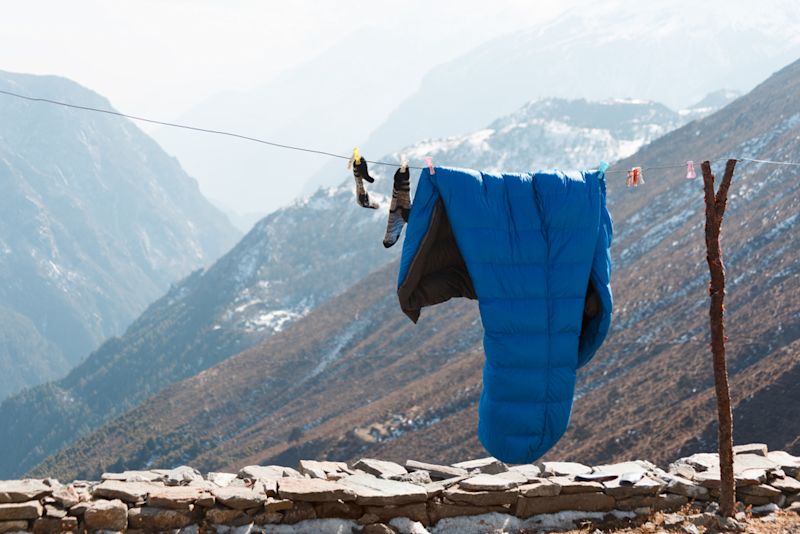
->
702;159;736;517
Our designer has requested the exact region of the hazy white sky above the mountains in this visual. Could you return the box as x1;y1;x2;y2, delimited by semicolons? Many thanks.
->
0;0;576;119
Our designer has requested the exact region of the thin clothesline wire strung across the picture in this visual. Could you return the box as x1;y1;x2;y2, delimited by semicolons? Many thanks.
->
0;89;800;174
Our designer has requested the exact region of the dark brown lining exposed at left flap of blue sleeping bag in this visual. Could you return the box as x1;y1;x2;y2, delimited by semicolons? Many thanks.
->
397;199;477;323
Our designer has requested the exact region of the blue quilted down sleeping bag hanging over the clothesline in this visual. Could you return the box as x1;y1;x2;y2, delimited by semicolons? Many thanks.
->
397;167;612;463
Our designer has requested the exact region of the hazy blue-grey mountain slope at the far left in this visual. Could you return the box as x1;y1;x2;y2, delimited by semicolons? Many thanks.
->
0;72;238;399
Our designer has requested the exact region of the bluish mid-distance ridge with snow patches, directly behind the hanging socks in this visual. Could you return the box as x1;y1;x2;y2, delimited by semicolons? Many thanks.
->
0;99;684;475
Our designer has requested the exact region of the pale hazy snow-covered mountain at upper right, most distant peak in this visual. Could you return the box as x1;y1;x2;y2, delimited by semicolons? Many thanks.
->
350;0;800;183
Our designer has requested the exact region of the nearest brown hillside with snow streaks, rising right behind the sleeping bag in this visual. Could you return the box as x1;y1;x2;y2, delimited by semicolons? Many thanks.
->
33;58;800;478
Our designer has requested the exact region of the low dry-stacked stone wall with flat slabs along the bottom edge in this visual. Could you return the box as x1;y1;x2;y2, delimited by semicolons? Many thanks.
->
0;444;800;533
